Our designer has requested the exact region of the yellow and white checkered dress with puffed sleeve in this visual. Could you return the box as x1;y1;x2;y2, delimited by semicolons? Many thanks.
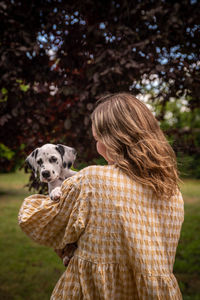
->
19;165;184;300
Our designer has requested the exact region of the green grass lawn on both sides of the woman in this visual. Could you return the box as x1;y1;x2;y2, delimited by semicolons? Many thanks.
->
0;172;200;300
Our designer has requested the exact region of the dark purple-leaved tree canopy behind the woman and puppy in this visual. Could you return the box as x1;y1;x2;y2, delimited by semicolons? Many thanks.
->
0;0;200;173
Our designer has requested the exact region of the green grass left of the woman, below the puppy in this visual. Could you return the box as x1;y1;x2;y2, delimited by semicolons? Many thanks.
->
0;172;64;300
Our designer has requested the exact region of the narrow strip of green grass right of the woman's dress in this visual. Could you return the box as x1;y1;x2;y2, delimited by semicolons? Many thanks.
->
174;179;200;300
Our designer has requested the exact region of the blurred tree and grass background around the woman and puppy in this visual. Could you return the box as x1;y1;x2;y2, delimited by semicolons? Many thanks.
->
0;0;200;300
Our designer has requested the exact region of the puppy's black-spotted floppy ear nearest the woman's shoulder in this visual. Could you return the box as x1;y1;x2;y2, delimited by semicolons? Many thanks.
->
56;144;77;169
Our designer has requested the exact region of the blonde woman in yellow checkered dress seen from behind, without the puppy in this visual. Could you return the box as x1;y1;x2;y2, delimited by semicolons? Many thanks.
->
19;93;184;300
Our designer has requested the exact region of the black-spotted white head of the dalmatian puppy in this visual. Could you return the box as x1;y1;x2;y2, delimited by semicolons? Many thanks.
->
26;144;76;182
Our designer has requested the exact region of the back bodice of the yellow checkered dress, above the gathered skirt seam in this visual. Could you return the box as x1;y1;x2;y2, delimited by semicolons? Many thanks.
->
77;165;183;268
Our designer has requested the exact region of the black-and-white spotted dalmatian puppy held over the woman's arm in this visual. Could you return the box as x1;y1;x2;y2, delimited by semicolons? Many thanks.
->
26;144;76;201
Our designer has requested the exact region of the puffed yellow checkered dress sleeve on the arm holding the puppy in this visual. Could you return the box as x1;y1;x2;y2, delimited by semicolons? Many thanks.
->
18;174;91;249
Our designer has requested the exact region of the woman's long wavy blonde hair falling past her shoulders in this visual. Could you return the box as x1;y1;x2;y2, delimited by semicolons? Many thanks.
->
91;93;179;198
